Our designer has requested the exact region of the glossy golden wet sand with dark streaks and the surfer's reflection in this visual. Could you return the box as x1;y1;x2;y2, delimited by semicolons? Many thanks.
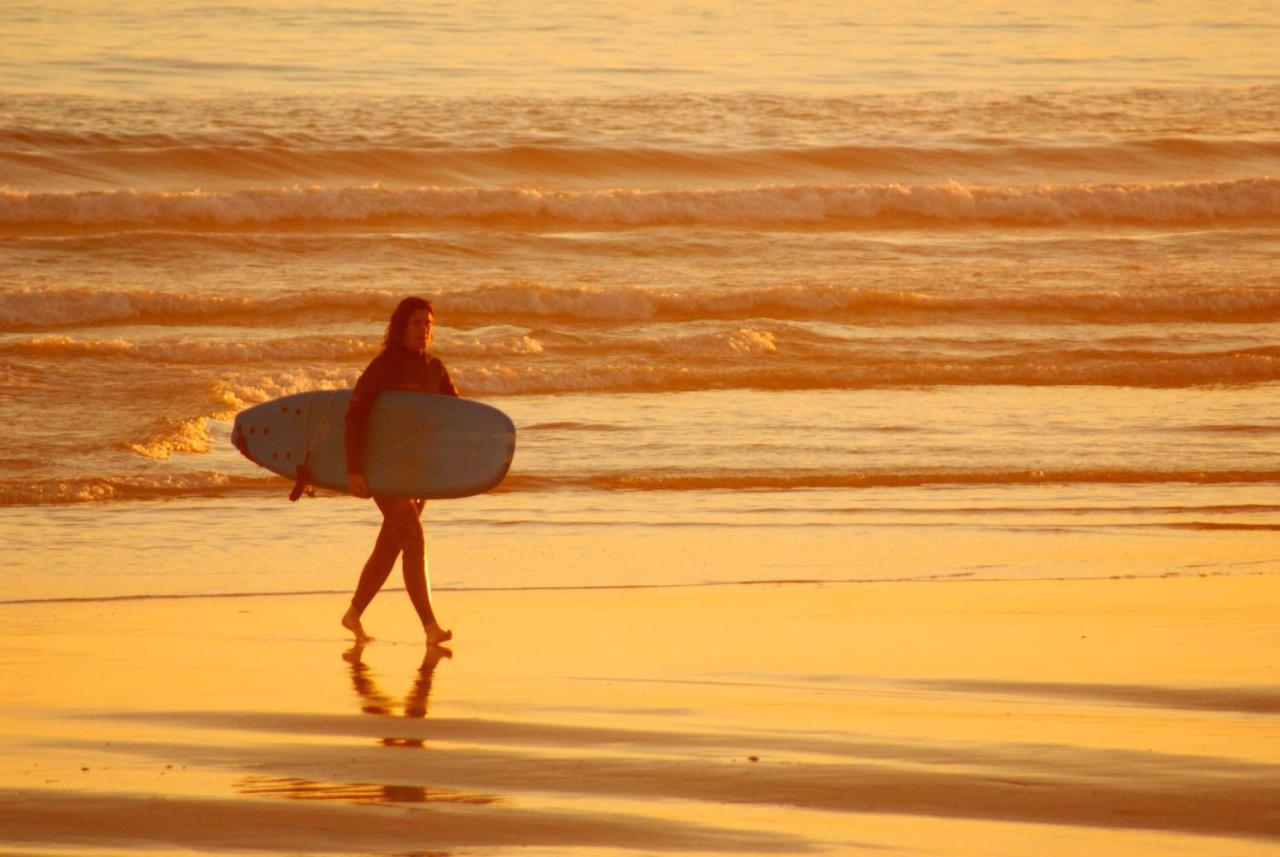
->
0;576;1280;856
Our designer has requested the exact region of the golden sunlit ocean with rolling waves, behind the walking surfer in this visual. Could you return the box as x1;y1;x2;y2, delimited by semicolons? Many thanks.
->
0;0;1280;603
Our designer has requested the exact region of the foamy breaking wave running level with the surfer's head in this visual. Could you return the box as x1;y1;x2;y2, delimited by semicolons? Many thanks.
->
10;283;1280;332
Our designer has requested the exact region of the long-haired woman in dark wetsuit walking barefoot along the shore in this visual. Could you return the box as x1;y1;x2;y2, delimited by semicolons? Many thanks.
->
342;298;458;646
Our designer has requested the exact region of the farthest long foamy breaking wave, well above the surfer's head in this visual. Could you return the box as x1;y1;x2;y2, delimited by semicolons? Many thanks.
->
0;178;1280;229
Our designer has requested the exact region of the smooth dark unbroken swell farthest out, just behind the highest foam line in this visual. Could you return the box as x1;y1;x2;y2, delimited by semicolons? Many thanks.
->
0;134;1280;187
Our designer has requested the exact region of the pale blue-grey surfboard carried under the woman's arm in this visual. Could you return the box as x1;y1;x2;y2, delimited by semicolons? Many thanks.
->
232;390;516;499
